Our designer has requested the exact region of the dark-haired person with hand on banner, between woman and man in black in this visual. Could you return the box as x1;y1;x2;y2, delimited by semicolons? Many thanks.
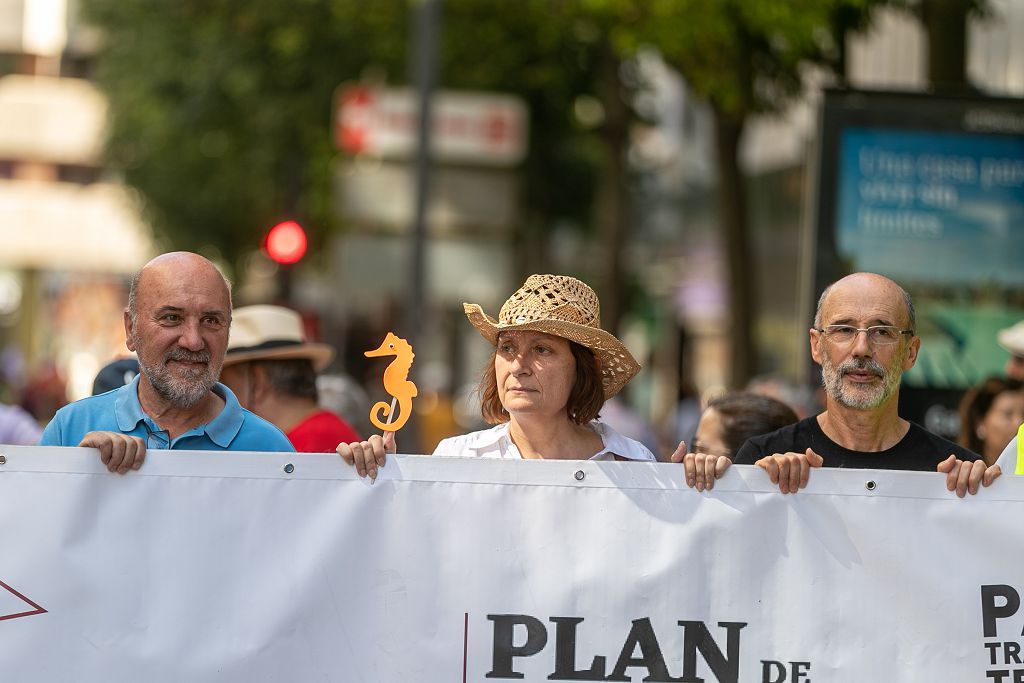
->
673;391;798;490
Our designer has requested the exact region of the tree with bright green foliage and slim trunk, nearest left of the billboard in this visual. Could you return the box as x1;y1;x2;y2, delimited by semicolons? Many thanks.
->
598;0;883;386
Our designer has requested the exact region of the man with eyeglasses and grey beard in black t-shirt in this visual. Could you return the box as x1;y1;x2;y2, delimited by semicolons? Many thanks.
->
735;272;1000;498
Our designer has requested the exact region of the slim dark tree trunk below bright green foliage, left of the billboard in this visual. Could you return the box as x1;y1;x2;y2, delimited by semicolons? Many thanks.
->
713;106;756;388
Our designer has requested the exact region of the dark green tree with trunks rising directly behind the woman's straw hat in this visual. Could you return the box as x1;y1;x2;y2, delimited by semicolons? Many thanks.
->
442;0;632;329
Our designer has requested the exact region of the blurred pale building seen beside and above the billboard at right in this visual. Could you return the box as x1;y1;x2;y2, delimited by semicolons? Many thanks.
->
742;0;1024;378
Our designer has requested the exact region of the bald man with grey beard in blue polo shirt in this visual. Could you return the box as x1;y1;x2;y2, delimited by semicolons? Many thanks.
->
40;252;294;474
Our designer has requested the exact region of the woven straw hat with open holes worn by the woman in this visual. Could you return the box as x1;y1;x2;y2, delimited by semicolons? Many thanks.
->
463;275;640;398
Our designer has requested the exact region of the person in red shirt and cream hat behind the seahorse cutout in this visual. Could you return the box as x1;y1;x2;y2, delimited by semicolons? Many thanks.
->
220;305;359;453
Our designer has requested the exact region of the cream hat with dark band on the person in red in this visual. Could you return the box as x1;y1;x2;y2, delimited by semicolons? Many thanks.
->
224;305;334;373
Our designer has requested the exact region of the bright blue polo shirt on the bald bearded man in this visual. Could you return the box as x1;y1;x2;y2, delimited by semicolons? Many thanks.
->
39;375;295;452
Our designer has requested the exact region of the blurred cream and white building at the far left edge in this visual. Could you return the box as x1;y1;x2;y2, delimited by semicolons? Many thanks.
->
0;0;155;405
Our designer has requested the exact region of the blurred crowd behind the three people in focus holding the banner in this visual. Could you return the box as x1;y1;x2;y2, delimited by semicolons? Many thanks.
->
0;259;1024;473
